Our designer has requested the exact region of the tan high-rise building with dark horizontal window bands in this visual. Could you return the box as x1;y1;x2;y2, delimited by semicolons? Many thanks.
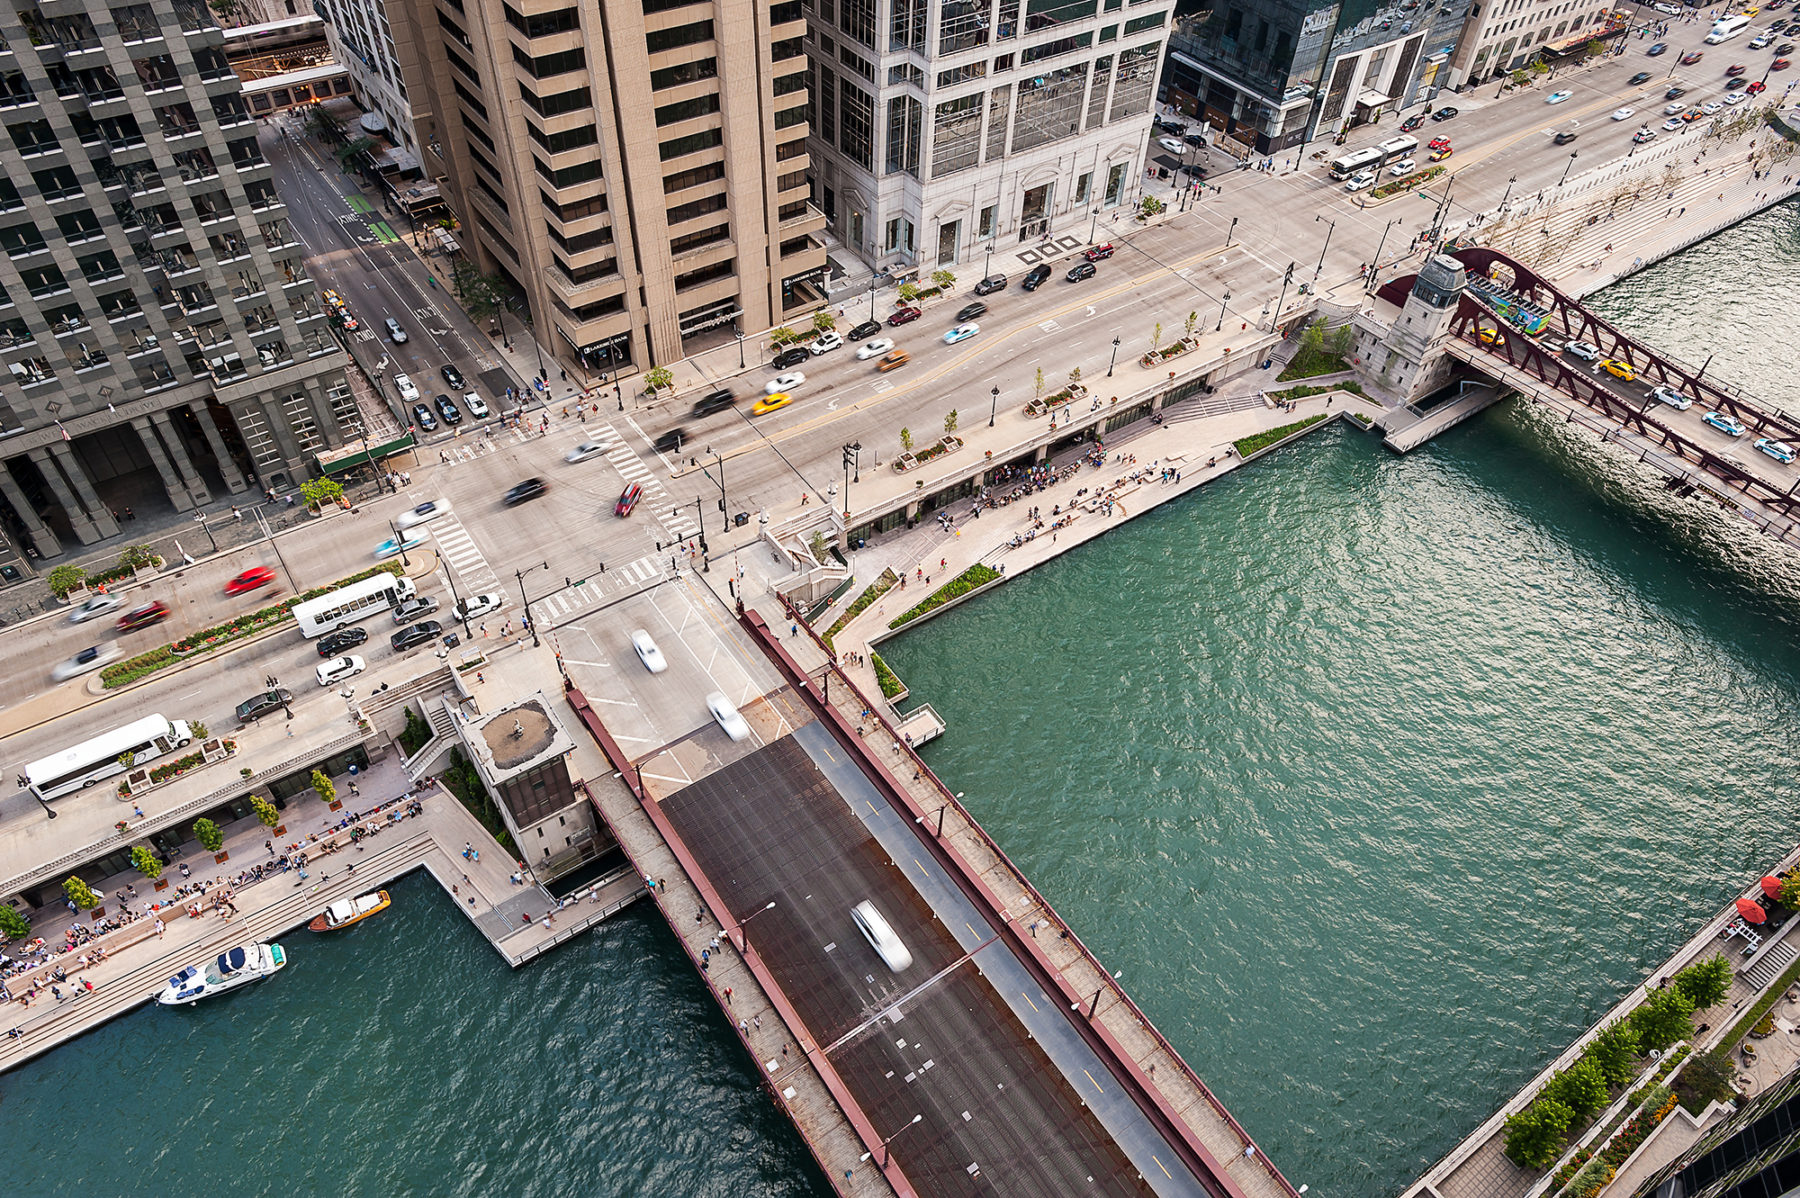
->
409;0;824;372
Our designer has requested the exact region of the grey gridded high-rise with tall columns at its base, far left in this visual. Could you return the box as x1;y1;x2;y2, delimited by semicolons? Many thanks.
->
0;0;356;558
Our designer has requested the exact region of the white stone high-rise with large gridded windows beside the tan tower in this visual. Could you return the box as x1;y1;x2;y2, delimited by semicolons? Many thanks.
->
808;0;1174;268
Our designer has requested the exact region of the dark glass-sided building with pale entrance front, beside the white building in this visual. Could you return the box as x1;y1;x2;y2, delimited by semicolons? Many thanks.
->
1163;0;1467;156
